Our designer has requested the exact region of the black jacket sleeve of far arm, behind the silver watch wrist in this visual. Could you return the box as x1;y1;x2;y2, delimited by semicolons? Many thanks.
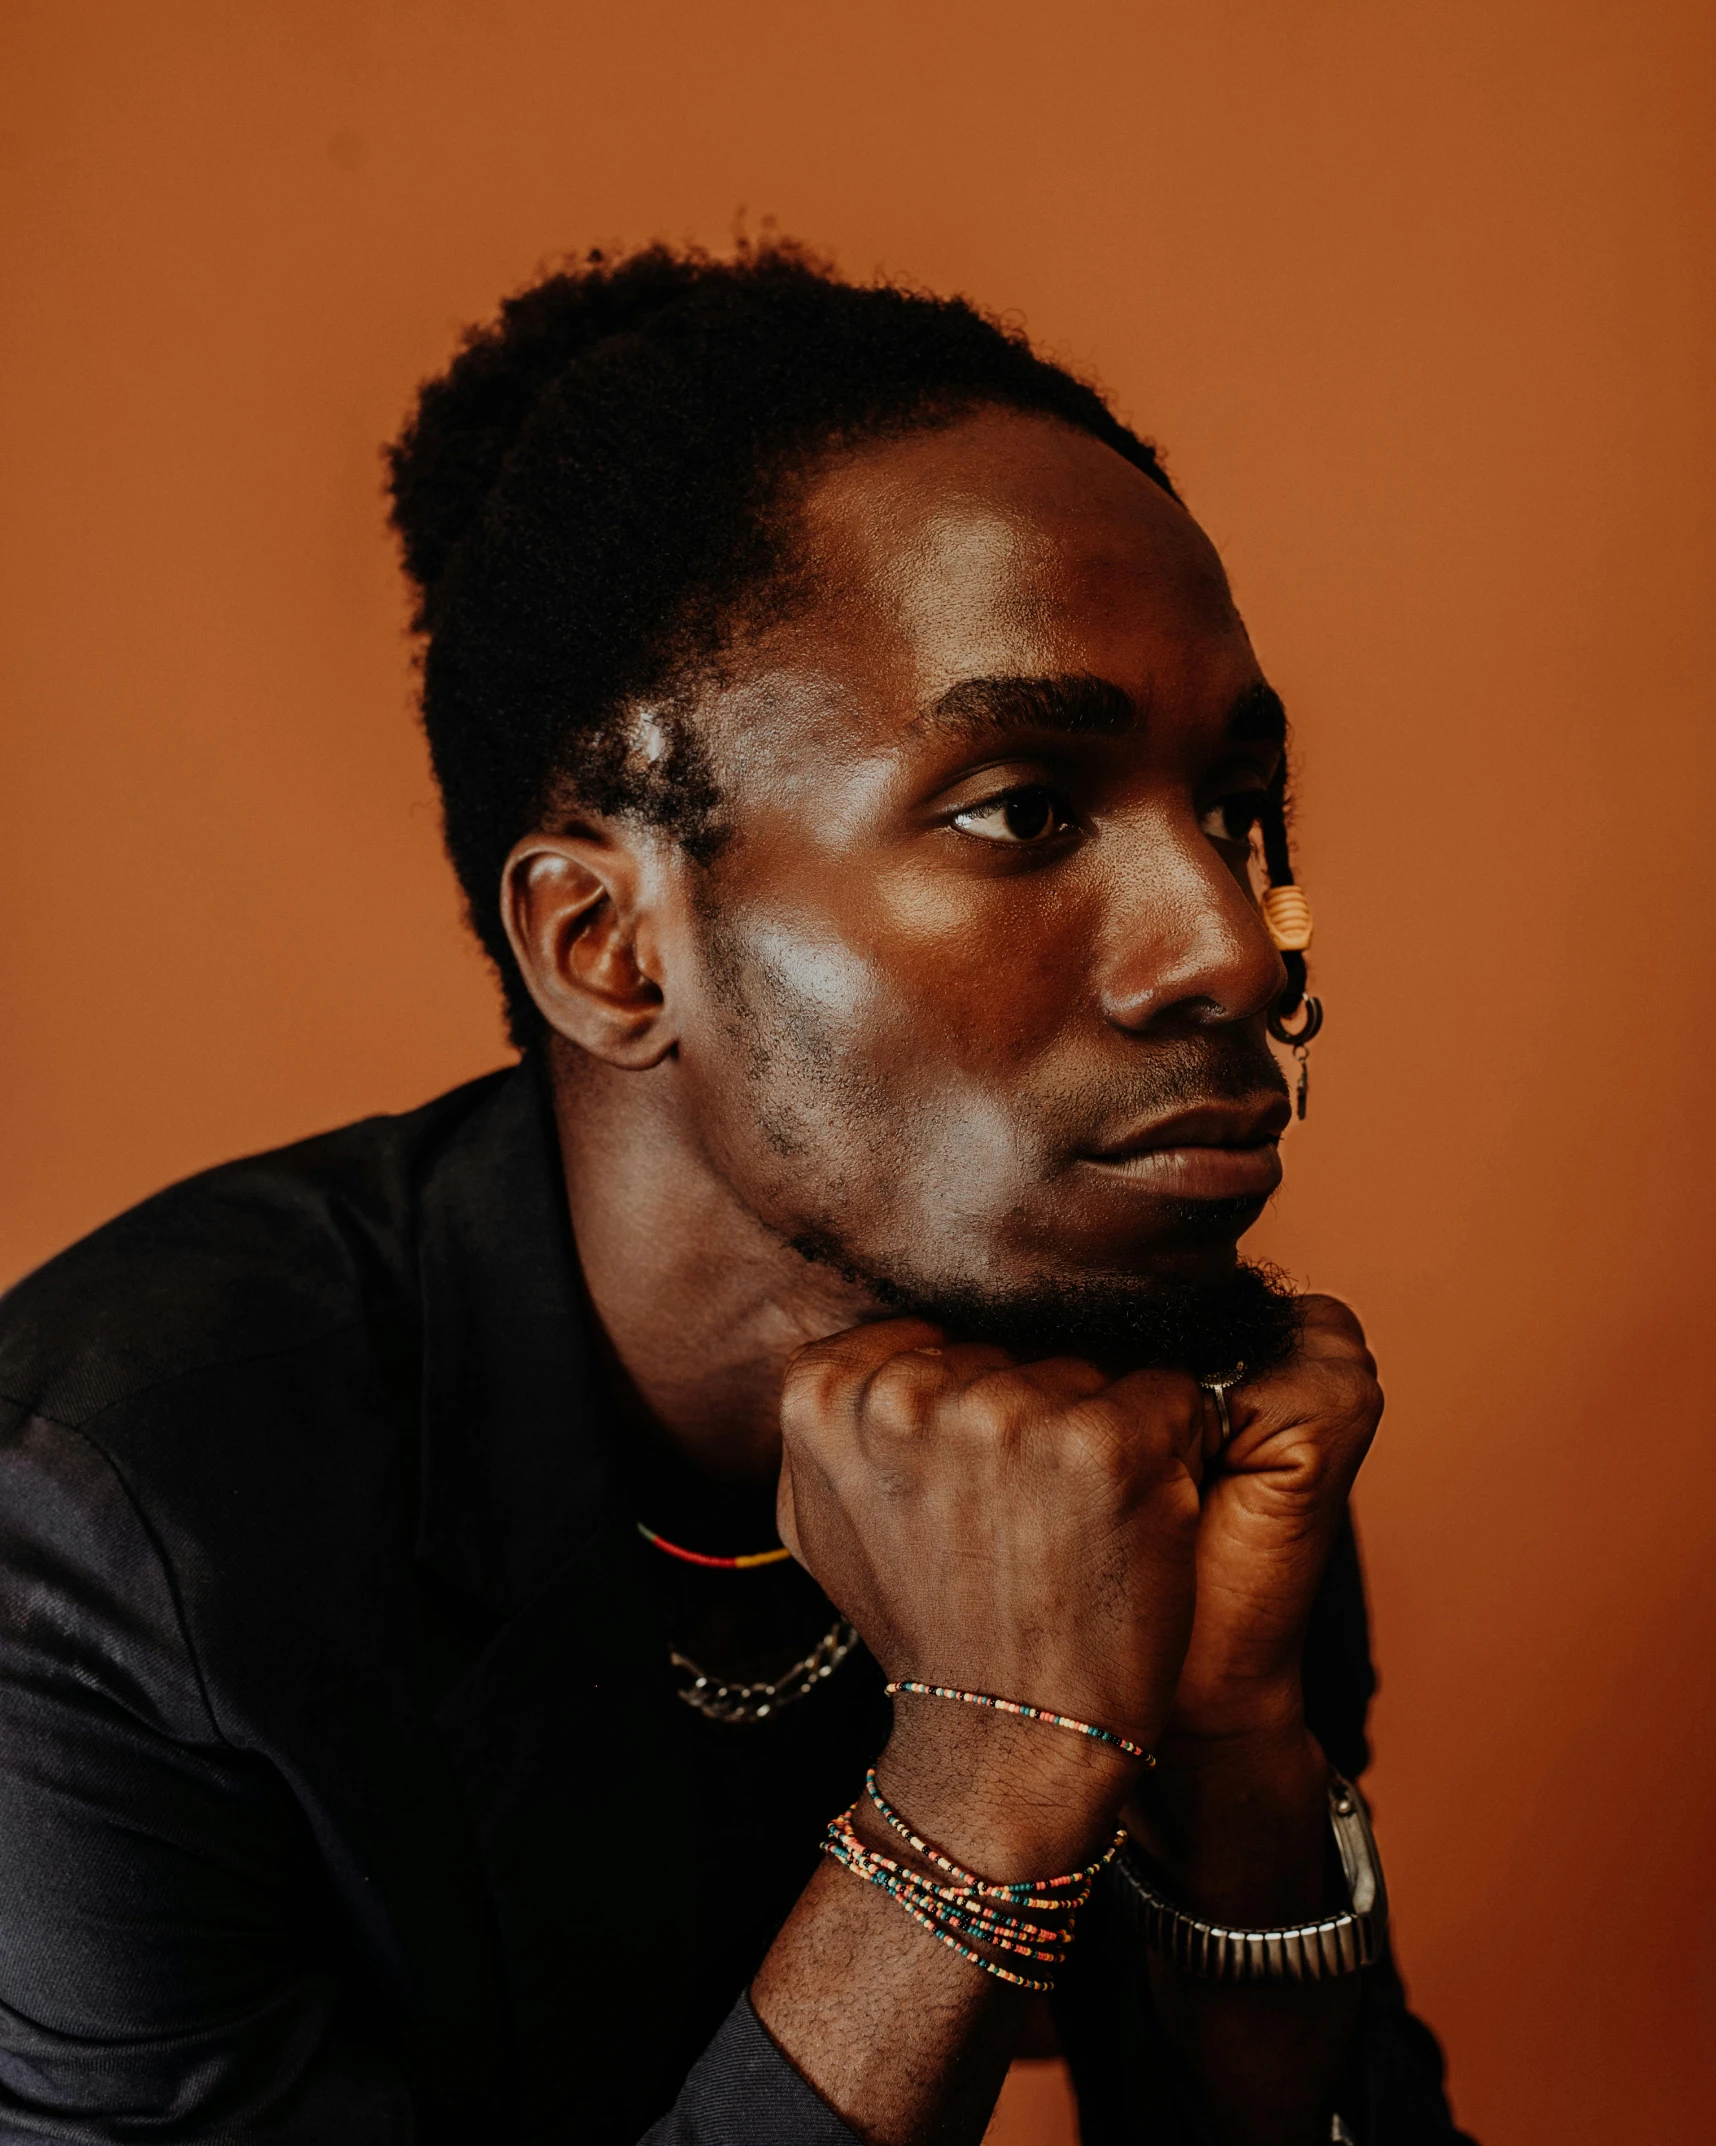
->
1055;1522;1471;2146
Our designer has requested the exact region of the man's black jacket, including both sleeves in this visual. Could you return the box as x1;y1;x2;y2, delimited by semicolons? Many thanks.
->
0;1064;1454;2146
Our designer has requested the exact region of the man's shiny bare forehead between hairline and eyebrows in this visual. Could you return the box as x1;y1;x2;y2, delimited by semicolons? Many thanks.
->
694;410;1257;773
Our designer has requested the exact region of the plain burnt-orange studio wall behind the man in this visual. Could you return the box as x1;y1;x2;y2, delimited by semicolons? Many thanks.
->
0;0;1716;2146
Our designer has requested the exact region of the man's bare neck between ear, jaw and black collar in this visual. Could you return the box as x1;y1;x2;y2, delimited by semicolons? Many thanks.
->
549;1039;875;1487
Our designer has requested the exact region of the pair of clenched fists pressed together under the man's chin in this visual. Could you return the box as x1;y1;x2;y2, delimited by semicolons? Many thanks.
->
779;1296;1381;1869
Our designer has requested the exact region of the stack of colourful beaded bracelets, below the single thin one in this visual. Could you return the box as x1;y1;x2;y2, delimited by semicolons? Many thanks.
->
822;1766;1126;1989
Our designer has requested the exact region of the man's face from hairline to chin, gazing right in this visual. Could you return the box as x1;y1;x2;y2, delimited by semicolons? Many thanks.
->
678;412;1287;1356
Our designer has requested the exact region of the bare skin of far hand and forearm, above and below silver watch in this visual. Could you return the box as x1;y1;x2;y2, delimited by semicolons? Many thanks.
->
1126;1296;1381;2146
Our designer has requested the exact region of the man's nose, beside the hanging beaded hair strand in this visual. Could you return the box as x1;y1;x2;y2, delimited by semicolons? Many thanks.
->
1096;811;1287;1032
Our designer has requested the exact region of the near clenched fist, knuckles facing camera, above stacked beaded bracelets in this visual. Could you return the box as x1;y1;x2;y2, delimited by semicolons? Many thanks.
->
779;1320;1203;1876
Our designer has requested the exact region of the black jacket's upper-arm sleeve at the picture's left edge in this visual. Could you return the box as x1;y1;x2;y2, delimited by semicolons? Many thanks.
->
0;1408;416;2146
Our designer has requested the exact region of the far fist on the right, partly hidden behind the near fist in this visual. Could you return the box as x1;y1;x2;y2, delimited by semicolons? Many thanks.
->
1169;1296;1381;1740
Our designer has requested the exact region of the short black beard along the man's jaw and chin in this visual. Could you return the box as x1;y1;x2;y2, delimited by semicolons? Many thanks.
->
792;1202;1300;1378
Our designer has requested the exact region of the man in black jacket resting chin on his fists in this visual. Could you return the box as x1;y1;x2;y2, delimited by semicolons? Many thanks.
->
0;249;1454;2146
